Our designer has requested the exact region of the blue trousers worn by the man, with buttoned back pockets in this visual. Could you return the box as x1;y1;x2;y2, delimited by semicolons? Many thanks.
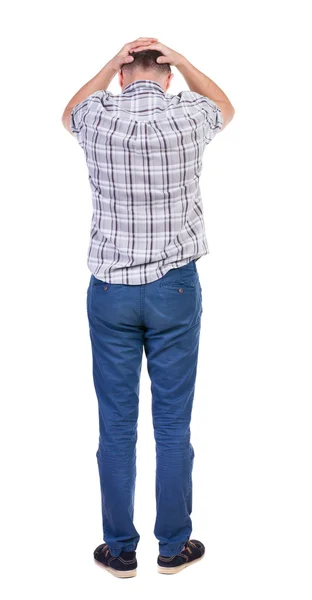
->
87;260;202;556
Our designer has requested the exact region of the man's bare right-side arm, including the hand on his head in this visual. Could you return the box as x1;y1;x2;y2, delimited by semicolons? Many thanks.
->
136;42;235;129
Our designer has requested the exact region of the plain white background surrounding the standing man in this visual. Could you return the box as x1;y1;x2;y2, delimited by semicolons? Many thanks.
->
0;0;312;600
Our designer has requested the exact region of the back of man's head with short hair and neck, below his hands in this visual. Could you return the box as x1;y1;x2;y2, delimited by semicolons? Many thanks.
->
118;50;174;92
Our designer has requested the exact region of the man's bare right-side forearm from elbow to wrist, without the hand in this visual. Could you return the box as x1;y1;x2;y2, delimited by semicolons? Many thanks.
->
175;55;235;129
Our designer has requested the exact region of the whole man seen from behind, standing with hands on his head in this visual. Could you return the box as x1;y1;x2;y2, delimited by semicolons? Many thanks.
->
62;38;234;577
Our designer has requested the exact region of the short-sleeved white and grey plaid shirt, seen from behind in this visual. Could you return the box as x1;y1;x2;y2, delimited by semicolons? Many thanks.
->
70;79;223;285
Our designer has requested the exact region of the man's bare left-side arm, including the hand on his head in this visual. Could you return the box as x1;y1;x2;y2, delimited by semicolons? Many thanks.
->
62;37;157;134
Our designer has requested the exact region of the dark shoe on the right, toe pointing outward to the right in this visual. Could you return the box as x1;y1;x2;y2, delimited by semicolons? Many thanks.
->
157;540;205;575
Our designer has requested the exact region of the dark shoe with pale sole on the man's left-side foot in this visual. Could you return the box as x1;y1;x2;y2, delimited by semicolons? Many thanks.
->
93;544;138;577
